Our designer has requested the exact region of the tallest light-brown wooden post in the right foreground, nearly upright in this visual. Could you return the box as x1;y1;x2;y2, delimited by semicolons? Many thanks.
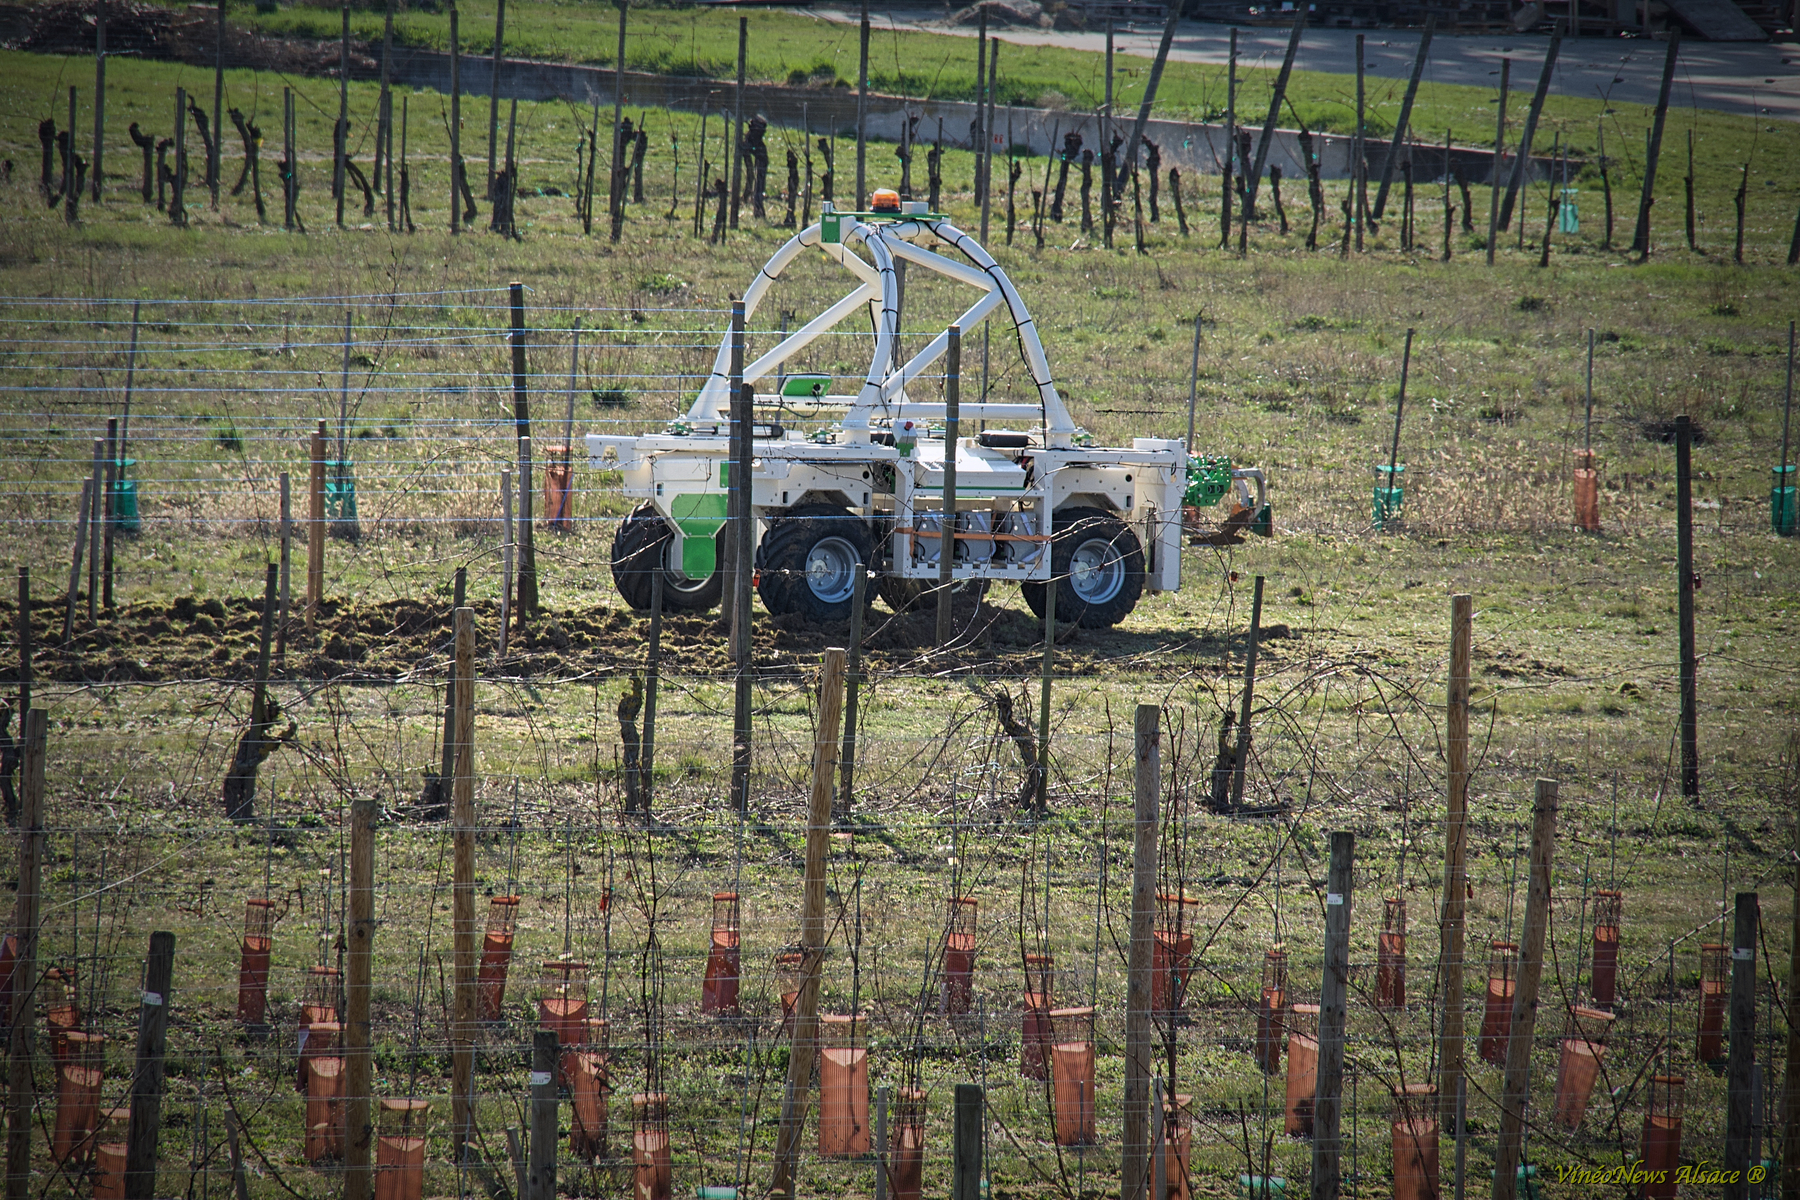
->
1438;594;1474;1126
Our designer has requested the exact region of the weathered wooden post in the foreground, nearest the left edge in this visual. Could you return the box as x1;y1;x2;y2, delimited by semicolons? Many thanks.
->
5;708;49;1200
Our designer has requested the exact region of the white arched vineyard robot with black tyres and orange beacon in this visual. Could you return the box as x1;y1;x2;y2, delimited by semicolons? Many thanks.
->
587;191;1269;628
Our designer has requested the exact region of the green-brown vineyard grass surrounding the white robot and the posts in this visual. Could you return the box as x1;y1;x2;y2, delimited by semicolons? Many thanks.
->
0;5;1800;1200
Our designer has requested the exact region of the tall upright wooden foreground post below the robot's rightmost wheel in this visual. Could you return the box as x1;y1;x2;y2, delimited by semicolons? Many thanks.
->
1120;703;1163;1200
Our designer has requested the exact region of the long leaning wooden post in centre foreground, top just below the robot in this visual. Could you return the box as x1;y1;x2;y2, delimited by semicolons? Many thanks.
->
769;646;844;1196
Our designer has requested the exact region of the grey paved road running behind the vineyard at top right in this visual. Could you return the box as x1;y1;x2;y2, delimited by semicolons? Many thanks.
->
812;7;1800;121
